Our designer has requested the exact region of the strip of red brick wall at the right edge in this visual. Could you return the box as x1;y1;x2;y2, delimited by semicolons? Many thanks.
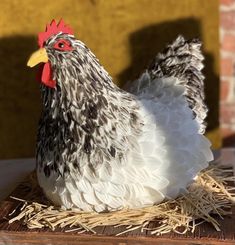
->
220;0;235;146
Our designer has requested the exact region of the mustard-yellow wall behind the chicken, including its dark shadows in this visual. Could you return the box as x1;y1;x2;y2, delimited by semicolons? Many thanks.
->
0;0;219;158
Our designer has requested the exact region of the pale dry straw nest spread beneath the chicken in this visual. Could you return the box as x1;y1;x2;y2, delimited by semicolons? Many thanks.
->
9;166;235;235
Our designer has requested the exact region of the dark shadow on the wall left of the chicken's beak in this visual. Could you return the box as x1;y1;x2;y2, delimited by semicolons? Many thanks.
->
0;36;40;159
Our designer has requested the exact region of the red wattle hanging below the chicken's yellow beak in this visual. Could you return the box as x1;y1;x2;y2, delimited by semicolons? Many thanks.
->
37;62;56;88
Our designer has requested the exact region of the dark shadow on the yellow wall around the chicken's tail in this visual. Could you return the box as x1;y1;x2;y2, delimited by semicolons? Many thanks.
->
118;18;219;136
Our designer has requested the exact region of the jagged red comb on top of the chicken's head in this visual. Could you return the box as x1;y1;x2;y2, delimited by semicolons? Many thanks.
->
38;19;73;48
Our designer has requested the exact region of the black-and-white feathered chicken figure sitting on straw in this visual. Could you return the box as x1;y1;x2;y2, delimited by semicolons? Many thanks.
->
28;20;213;212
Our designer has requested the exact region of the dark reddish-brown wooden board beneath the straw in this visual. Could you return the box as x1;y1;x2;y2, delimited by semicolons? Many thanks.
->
0;178;235;245
